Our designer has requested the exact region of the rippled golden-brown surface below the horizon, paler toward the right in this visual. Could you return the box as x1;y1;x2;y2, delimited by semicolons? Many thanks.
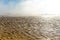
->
0;17;60;40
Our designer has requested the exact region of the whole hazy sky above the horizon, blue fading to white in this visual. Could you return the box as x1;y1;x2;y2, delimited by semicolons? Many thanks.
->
0;0;60;17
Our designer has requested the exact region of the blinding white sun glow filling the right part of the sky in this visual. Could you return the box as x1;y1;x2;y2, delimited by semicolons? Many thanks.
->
17;0;60;17
